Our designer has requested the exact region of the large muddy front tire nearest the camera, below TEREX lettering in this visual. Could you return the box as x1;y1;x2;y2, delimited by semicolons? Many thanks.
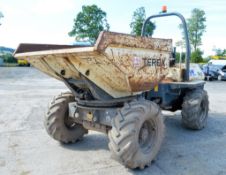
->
108;100;164;169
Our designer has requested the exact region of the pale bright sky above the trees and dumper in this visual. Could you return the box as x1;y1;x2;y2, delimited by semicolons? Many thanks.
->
0;0;226;56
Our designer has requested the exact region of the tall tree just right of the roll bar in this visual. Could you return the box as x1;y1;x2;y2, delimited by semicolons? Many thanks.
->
180;8;206;51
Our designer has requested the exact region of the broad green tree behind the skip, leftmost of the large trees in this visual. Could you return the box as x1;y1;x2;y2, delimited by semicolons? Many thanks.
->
68;5;110;44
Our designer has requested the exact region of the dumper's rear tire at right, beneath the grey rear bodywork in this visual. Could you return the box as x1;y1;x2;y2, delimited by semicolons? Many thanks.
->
181;89;209;130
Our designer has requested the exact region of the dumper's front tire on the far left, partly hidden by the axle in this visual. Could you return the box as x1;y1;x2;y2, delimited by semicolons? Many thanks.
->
44;92;87;143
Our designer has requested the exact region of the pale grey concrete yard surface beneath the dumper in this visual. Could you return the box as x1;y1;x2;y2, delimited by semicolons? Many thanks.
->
0;67;226;175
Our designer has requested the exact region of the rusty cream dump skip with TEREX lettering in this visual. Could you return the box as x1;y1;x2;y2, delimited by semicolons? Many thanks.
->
15;32;181;98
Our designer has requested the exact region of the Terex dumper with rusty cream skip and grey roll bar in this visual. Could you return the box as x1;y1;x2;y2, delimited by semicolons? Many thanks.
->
14;13;209;169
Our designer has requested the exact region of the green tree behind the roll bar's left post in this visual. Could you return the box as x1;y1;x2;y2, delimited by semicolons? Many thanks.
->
130;7;156;36
